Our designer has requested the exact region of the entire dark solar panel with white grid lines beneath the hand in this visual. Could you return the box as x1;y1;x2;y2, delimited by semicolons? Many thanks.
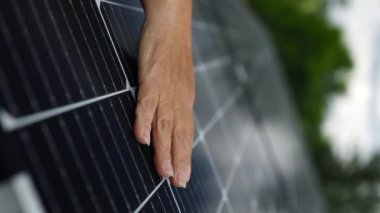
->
0;0;324;212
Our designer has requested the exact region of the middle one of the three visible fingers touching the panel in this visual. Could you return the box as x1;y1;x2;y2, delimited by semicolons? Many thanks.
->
153;101;174;177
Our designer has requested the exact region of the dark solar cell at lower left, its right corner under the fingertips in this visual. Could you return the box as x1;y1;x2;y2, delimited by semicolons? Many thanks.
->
2;94;160;212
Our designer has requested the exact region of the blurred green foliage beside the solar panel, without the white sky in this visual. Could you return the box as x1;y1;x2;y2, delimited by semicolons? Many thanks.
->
248;0;380;212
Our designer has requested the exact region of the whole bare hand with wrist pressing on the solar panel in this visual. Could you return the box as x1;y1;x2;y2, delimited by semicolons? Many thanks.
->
134;0;195;187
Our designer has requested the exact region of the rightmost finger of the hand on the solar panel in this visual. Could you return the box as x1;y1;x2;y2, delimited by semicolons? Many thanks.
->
171;109;194;188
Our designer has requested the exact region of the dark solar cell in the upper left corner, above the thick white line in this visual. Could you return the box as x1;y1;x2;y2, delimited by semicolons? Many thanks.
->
0;1;126;116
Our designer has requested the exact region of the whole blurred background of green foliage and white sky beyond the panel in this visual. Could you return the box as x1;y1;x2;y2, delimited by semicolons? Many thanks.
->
247;0;380;212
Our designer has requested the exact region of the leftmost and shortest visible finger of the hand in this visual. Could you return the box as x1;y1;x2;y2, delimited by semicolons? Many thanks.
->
134;81;159;145
